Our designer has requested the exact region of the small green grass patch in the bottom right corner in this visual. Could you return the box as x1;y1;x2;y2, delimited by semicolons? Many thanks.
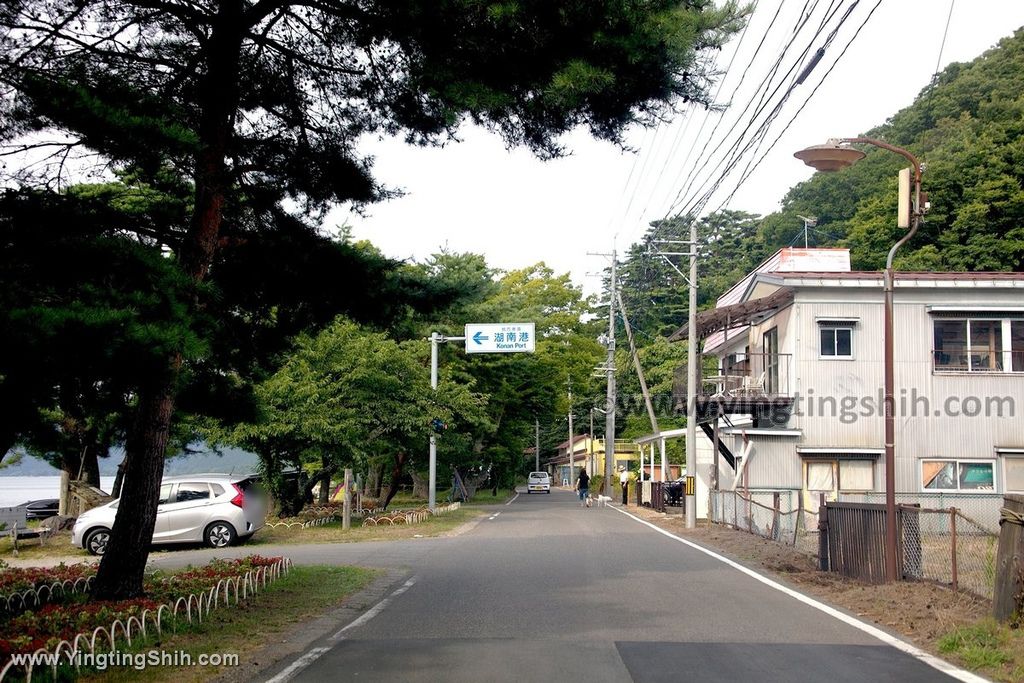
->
938;618;1024;683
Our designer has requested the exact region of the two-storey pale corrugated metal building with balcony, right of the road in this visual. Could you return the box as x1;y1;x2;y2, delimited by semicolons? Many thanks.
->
674;249;1024;520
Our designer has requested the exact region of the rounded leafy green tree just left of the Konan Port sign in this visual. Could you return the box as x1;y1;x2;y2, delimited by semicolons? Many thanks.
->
228;319;484;513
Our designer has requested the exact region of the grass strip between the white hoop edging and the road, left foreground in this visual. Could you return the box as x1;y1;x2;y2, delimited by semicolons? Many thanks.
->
81;566;379;683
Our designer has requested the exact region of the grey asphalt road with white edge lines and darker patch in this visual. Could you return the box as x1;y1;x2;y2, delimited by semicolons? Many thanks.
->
155;490;962;683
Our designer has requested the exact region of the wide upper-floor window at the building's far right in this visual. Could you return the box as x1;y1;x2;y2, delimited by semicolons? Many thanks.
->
933;318;1024;373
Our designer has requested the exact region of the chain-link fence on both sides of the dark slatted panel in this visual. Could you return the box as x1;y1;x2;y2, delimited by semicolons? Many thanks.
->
711;490;998;599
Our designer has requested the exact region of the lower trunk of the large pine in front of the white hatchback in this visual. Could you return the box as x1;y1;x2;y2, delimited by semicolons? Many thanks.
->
92;380;174;600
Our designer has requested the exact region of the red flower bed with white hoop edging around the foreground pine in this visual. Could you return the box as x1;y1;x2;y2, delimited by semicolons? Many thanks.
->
0;555;290;680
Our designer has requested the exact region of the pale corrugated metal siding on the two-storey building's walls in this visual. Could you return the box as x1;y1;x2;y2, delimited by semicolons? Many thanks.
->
786;286;1024;492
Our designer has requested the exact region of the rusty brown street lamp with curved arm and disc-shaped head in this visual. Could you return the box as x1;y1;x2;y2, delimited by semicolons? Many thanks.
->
794;137;926;582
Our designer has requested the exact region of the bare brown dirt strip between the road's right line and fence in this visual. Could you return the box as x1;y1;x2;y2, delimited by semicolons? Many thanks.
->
628;506;991;658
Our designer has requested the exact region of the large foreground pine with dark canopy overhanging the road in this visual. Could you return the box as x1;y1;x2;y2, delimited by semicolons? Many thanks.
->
0;0;738;598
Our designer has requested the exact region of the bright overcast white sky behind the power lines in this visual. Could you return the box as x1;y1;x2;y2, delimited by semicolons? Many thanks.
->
331;0;1024;292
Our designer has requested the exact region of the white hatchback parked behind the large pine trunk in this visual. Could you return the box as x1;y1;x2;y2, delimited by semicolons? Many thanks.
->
72;474;266;555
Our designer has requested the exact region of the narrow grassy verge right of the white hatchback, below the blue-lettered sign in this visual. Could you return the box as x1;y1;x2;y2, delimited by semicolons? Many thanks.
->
246;506;484;546
